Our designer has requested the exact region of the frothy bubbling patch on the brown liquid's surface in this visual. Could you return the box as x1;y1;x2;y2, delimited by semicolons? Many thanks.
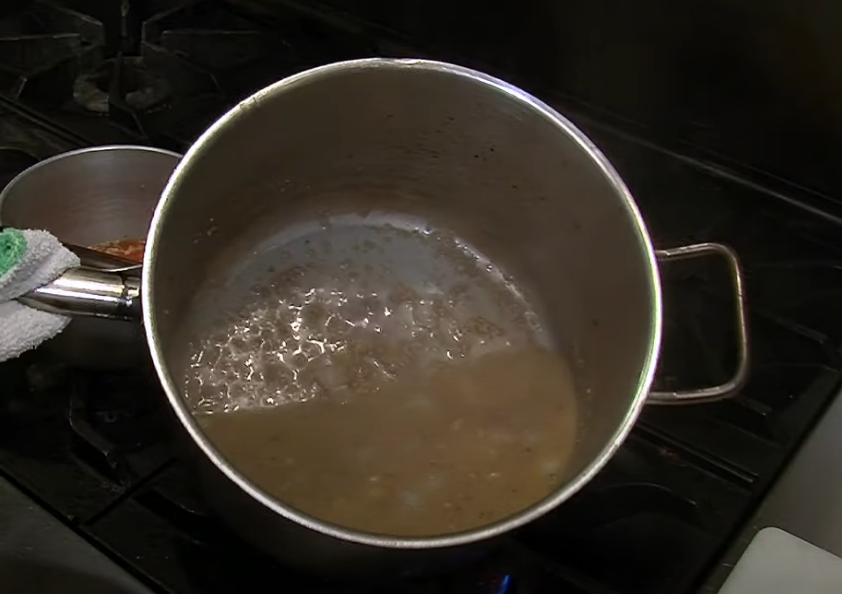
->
184;221;540;414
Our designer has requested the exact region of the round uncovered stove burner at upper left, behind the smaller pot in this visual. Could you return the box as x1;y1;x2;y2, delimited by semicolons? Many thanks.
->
73;57;172;114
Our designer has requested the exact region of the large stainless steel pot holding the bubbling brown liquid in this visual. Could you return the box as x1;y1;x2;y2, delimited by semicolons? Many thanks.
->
16;59;748;569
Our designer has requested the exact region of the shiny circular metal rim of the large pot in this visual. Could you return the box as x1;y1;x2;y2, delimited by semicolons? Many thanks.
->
141;58;662;549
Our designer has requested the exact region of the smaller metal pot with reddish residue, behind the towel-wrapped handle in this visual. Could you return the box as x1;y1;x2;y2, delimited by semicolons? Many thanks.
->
0;145;181;368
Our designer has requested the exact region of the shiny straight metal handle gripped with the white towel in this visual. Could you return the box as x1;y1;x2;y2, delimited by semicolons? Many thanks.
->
18;266;142;321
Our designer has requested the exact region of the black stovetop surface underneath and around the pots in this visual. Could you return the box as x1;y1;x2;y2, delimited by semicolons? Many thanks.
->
0;0;842;594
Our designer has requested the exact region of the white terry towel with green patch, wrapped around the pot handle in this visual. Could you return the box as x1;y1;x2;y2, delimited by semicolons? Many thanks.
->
0;228;79;361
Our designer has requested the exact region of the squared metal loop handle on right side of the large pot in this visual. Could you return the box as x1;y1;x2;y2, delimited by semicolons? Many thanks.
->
647;243;749;404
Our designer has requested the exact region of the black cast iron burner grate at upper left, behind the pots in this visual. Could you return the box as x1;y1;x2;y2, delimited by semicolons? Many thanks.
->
0;0;375;150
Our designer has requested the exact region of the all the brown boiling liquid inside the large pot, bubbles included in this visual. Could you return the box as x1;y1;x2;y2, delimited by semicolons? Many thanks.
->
184;223;577;536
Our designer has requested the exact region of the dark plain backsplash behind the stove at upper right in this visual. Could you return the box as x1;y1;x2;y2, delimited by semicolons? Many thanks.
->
237;0;842;199
